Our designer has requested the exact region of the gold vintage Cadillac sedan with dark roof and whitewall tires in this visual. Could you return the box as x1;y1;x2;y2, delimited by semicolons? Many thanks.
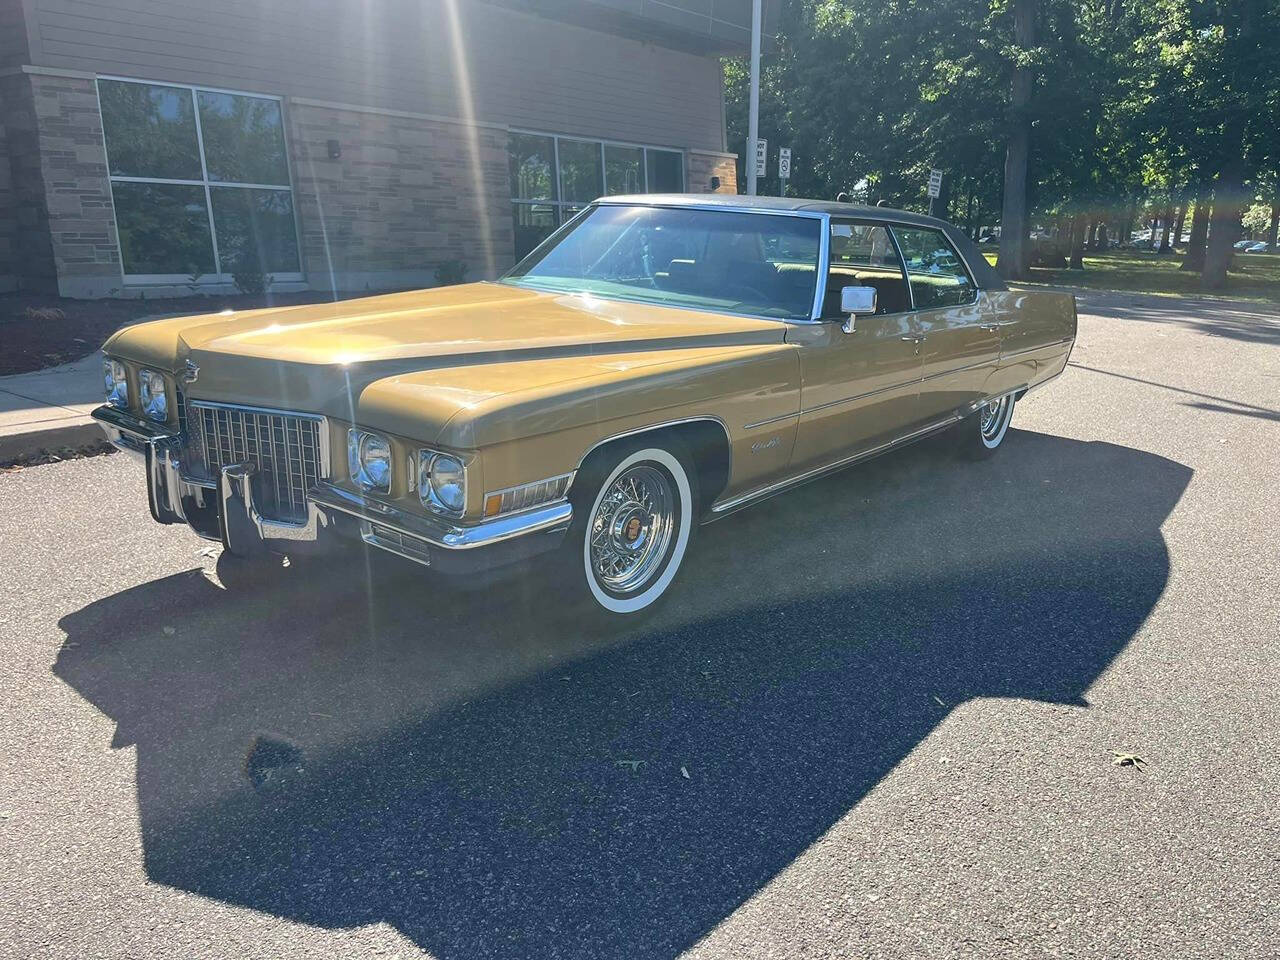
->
93;195;1076;614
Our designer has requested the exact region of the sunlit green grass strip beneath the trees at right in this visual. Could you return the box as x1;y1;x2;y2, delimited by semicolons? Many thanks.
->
983;250;1280;302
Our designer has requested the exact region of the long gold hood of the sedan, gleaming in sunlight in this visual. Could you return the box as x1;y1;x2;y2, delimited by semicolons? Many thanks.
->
105;283;786;435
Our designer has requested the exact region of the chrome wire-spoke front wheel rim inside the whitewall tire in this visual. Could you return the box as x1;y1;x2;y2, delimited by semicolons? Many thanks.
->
589;463;678;595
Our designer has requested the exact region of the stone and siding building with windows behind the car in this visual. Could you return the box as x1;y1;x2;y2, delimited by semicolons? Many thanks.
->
0;0;751;297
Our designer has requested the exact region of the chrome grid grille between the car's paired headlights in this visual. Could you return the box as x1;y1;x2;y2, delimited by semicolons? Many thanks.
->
180;401;328;524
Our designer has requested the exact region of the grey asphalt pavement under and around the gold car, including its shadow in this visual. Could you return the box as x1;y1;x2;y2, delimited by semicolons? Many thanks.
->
0;294;1280;960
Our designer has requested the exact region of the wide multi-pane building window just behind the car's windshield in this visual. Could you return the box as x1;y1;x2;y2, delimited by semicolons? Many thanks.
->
508;133;685;260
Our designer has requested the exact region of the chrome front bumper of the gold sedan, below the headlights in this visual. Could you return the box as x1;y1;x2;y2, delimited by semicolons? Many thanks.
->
92;406;573;572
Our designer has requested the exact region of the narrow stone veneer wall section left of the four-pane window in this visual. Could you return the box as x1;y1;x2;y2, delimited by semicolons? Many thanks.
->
24;74;122;297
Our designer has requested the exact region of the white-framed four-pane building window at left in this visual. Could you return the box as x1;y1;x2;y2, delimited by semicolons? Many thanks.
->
97;78;301;283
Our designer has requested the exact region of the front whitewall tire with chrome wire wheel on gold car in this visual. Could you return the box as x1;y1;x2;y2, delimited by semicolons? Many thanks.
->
566;440;698;616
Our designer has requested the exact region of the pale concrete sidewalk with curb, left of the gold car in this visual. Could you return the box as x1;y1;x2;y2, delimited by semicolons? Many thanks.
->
0;351;105;462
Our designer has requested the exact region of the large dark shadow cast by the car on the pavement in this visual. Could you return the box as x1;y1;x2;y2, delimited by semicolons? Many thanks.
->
55;431;1190;957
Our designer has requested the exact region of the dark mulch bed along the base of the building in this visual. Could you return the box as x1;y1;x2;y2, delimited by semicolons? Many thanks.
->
0;292;367;376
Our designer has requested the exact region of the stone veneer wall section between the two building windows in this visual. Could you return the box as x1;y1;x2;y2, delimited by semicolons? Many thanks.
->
288;99;515;291
